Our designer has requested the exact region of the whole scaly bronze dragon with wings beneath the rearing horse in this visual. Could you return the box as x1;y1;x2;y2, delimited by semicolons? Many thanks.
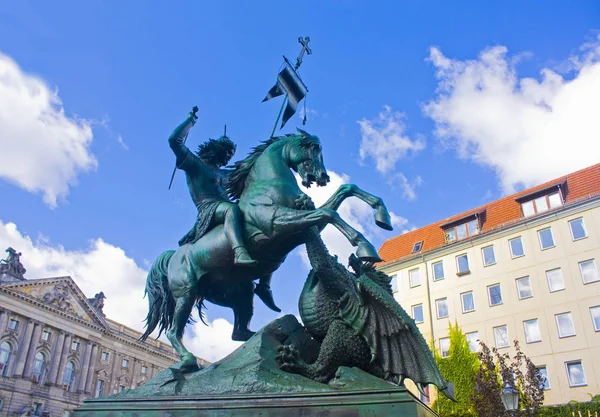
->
277;228;453;399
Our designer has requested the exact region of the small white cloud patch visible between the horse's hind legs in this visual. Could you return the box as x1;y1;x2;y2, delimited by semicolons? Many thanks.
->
183;318;242;362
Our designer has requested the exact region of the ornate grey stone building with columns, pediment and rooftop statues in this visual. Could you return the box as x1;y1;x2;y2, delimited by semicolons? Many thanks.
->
0;249;190;417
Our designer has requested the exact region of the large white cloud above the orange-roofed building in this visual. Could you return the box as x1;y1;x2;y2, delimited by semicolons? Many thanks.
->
423;37;600;193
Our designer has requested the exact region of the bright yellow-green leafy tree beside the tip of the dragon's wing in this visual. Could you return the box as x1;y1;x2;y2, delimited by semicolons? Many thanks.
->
432;324;479;417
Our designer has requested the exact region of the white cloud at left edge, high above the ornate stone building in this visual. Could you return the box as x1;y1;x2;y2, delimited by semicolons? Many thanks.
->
0;53;97;207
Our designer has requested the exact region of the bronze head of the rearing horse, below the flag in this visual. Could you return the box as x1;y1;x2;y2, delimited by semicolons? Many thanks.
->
289;129;329;187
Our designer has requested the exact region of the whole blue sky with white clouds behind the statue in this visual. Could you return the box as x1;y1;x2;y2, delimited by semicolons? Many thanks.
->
0;0;600;361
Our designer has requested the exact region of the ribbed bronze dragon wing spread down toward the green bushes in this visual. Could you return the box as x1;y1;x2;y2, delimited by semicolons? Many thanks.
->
339;274;452;398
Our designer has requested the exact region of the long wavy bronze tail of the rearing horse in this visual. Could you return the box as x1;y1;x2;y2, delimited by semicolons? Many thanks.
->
140;250;175;341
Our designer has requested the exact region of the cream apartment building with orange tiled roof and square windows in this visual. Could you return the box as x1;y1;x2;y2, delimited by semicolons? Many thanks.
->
379;165;600;404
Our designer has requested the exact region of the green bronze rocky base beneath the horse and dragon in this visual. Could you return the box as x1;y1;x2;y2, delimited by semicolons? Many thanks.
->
74;315;435;417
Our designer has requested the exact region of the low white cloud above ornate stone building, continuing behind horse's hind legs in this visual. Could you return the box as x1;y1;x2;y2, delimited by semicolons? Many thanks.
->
0;220;240;361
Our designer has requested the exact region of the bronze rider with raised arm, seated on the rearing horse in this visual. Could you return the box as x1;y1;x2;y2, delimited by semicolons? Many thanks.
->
169;107;281;311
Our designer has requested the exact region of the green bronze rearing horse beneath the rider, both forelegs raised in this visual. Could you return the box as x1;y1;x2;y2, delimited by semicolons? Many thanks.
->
141;129;392;372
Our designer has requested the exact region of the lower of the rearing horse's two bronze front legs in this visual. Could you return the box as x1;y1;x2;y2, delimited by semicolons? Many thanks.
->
273;207;381;262
